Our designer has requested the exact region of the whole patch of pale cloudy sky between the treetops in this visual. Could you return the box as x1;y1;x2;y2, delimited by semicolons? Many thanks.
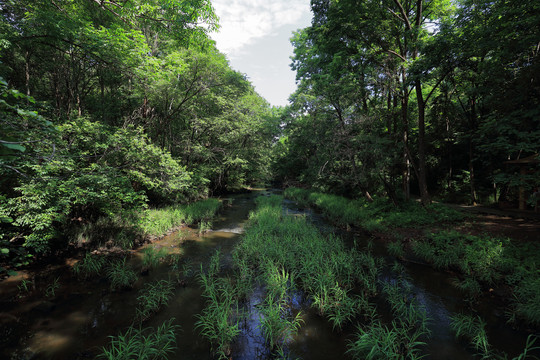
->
211;0;311;106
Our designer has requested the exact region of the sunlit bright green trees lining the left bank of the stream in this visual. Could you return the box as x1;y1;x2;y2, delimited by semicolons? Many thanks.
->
0;0;279;263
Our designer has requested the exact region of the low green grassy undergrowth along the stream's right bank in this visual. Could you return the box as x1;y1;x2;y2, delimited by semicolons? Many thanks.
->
285;188;540;332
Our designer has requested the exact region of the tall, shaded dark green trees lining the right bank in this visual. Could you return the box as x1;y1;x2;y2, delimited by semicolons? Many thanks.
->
274;0;540;204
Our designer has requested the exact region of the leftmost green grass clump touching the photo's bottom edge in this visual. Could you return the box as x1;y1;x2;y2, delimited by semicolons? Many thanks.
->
97;318;180;360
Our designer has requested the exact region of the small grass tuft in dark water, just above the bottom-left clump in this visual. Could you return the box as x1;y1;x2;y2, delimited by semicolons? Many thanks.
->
136;280;174;321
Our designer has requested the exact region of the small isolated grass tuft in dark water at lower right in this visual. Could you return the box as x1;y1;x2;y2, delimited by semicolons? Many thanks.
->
450;314;491;358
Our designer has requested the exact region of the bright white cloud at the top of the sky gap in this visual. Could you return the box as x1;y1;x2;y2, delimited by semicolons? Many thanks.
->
211;0;309;58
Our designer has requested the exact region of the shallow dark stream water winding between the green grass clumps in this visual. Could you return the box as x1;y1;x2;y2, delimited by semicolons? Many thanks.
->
0;190;527;360
